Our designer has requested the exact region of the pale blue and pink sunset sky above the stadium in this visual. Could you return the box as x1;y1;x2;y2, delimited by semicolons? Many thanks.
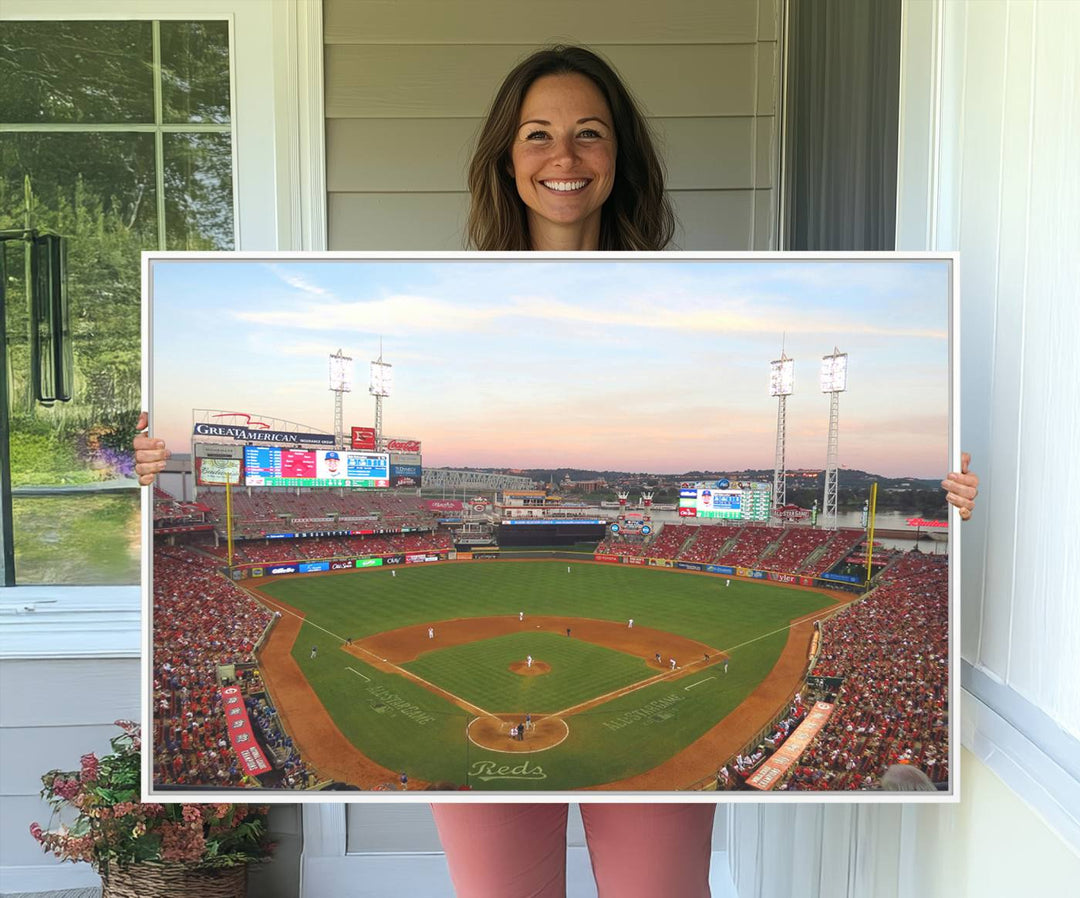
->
150;253;948;478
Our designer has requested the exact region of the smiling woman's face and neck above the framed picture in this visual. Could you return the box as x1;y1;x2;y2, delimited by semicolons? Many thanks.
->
510;75;617;250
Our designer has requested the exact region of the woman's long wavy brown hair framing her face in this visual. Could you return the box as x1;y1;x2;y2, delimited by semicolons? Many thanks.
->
469;46;675;250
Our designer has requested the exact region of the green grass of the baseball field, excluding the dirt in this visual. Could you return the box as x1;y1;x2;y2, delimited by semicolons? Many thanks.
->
258;561;831;791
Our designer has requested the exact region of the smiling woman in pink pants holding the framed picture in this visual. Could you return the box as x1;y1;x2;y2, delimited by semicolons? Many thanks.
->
135;46;977;898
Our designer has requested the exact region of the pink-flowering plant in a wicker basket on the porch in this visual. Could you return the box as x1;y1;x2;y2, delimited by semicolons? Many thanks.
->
30;721;273;898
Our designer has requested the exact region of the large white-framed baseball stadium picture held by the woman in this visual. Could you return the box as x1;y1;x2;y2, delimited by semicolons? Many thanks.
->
144;253;956;801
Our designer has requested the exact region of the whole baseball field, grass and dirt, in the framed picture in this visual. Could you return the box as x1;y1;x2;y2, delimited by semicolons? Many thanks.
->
247;561;851;791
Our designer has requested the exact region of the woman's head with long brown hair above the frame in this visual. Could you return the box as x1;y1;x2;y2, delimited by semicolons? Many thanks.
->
469;46;675;255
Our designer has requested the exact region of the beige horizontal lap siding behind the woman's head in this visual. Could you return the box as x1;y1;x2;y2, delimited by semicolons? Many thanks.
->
324;0;779;250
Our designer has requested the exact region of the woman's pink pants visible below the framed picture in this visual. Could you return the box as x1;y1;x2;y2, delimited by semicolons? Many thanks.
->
432;804;716;898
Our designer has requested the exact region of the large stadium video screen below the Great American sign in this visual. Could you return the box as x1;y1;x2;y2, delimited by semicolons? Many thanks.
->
244;446;390;488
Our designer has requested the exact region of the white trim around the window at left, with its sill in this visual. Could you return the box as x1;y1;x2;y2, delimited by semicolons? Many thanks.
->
0;0;326;658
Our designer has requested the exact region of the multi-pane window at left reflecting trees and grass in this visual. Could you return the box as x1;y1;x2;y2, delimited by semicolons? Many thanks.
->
0;19;235;585
